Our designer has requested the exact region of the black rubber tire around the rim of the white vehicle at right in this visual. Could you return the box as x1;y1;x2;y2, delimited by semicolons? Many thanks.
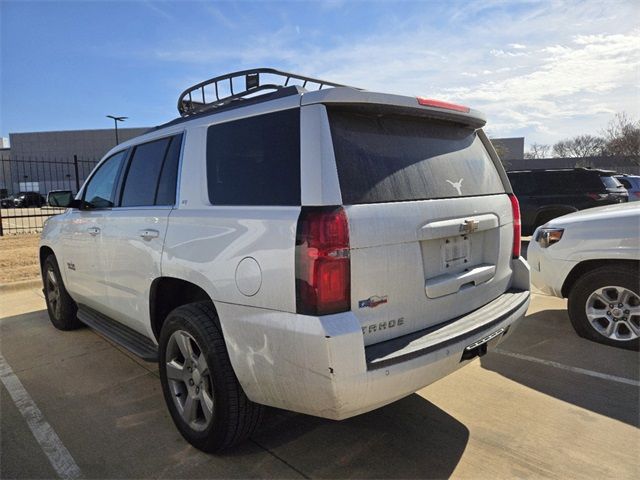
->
568;264;640;350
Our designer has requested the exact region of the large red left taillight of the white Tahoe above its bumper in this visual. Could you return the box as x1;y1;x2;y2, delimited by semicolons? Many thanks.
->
296;207;351;315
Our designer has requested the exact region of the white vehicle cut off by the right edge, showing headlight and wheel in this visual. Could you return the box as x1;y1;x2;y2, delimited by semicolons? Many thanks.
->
527;203;640;350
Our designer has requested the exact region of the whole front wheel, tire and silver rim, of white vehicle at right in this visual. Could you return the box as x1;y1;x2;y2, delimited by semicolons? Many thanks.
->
568;265;640;350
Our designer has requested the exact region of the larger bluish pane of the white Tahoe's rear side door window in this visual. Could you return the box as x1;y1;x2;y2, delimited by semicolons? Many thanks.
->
121;138;170;207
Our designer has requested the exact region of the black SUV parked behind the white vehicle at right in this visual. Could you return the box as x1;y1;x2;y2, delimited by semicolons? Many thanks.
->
507;168;628;235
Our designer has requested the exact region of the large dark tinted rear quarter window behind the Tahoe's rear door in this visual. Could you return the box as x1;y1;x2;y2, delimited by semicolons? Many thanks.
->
207;108;300;205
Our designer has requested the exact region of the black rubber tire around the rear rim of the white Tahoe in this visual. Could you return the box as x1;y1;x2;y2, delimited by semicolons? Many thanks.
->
158;302;264;453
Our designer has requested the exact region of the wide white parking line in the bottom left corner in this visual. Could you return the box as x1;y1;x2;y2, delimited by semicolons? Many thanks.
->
0;355;82;479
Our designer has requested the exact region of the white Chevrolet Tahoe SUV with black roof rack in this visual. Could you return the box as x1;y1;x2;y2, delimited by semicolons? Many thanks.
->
40;69;529;452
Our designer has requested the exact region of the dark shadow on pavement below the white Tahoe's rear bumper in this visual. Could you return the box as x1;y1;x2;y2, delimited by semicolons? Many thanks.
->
248;394;469;478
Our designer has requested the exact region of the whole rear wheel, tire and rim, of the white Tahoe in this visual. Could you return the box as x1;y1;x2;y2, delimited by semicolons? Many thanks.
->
159;302;264;452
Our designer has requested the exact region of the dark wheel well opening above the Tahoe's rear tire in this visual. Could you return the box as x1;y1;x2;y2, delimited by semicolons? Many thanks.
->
149;277;215;340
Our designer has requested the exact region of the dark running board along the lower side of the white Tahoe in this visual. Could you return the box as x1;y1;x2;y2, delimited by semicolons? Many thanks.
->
78;305;158;362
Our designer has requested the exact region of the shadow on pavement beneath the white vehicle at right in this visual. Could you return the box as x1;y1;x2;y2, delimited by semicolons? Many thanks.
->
480;309;640;426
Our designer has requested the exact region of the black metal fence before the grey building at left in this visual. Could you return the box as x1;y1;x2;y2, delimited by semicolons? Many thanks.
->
0;155;98;236
